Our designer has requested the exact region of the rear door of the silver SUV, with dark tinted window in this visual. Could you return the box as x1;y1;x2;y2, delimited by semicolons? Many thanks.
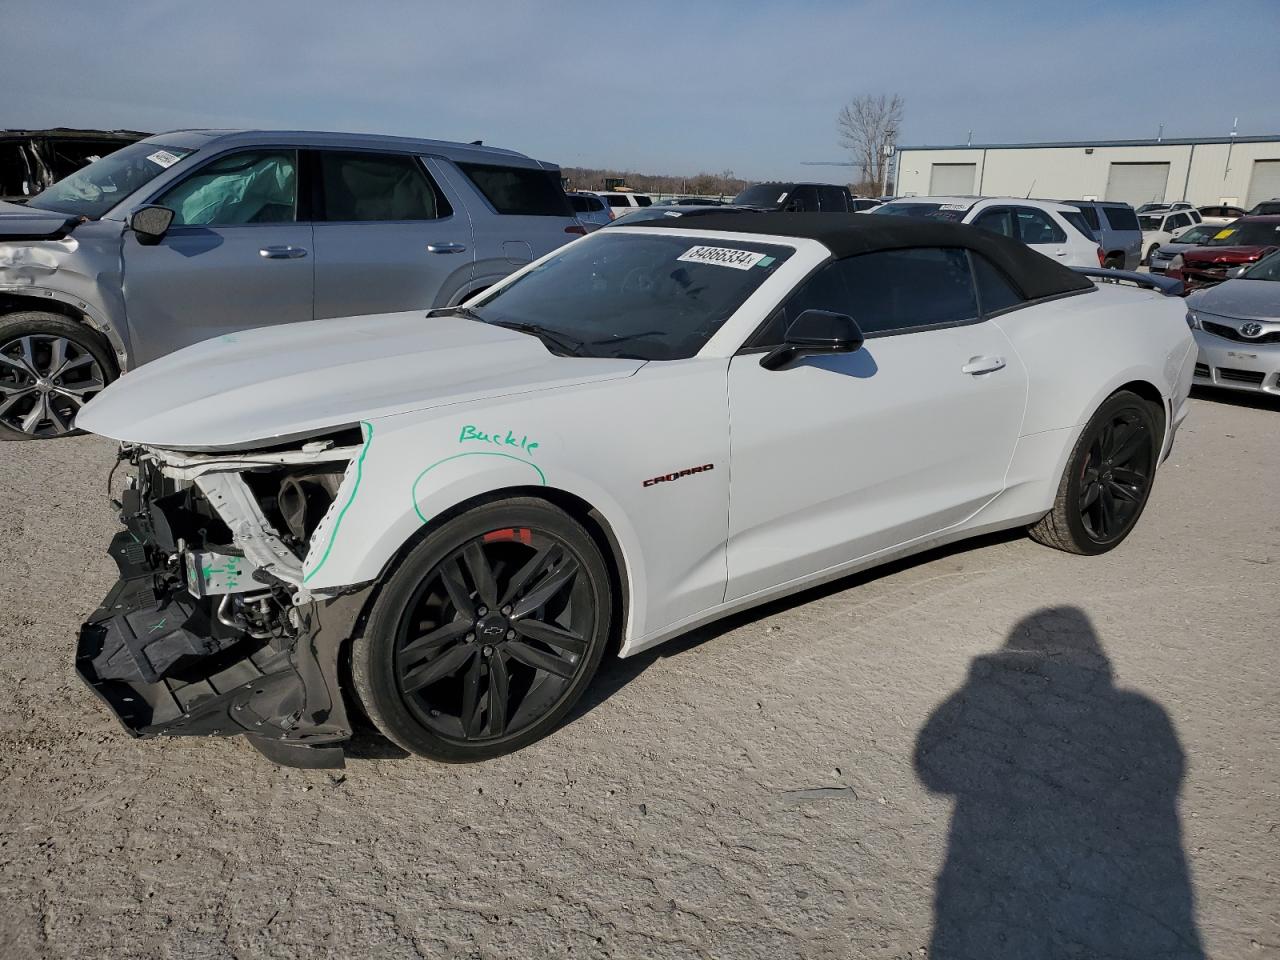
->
312;150;475;319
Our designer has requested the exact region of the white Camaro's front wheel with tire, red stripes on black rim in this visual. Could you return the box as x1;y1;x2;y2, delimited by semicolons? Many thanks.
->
352;498;613;763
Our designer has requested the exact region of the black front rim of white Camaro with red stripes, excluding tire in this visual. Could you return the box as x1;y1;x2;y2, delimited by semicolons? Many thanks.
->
394;527;599;745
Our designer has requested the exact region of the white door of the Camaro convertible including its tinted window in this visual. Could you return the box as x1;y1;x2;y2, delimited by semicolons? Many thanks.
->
727;250;1027;599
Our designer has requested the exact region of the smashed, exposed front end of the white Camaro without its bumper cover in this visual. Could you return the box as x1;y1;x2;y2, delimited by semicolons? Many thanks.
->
76;428;371;767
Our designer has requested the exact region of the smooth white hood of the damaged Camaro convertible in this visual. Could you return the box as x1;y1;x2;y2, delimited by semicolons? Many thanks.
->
76;311;645;449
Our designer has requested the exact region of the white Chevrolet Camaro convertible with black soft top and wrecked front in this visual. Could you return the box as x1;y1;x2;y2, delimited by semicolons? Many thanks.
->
77;214;1196;765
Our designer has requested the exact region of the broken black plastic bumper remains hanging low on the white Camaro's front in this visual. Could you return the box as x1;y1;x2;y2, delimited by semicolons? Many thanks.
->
76;453;369;767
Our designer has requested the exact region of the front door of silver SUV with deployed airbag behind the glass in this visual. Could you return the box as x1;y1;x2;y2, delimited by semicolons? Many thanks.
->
123;147;314;364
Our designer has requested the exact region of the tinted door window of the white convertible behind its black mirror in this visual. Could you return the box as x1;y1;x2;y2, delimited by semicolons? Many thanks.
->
753;247;972;347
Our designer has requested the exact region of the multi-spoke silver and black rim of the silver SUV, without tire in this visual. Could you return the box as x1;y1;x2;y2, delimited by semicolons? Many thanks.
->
0;333;106;438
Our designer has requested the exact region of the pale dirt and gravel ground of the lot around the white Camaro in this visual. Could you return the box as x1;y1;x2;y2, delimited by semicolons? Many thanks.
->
0;398;1280;960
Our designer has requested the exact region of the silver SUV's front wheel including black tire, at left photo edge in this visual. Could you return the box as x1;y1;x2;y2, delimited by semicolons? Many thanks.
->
0;310;116;440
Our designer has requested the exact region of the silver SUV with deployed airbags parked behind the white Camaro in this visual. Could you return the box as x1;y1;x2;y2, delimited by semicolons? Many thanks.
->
0;131;585;440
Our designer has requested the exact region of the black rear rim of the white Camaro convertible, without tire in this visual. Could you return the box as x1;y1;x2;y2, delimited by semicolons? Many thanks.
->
1080;410;1155;543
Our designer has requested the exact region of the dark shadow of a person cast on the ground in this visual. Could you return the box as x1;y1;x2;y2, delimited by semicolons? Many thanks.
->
915;607;1204;960
